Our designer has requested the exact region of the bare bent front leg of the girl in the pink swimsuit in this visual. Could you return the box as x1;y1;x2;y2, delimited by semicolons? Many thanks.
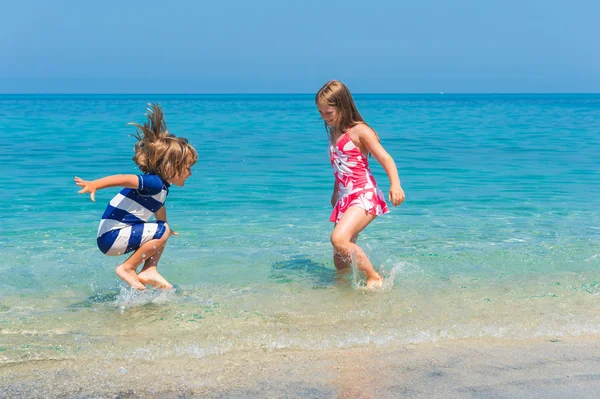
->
331;206;383;288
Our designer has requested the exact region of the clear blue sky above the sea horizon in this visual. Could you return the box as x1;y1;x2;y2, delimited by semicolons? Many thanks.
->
0;0;600;93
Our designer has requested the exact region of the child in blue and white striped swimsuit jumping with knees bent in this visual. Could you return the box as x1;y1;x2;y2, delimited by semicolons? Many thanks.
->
75;104;198;290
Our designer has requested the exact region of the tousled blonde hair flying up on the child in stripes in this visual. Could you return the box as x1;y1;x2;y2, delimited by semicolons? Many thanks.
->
128;103;198;180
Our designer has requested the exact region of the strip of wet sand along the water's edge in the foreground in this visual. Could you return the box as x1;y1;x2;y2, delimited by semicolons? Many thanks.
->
0;336;600;399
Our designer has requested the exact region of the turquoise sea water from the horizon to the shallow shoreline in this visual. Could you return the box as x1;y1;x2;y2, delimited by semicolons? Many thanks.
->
0;94;600;374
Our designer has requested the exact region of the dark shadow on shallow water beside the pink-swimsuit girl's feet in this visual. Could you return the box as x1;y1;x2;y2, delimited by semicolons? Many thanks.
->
269;255;338;288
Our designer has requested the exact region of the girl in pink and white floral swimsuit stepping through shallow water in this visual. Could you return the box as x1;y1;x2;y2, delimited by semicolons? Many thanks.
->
315;80;404;288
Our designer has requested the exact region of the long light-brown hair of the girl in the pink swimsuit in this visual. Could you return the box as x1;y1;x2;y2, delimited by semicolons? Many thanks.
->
315;80;368;143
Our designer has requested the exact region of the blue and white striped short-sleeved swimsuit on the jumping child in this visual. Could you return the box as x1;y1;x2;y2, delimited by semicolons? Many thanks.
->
96;174;169;256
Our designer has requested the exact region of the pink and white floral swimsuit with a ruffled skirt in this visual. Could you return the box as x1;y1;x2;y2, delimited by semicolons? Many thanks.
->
329;131;389;223
